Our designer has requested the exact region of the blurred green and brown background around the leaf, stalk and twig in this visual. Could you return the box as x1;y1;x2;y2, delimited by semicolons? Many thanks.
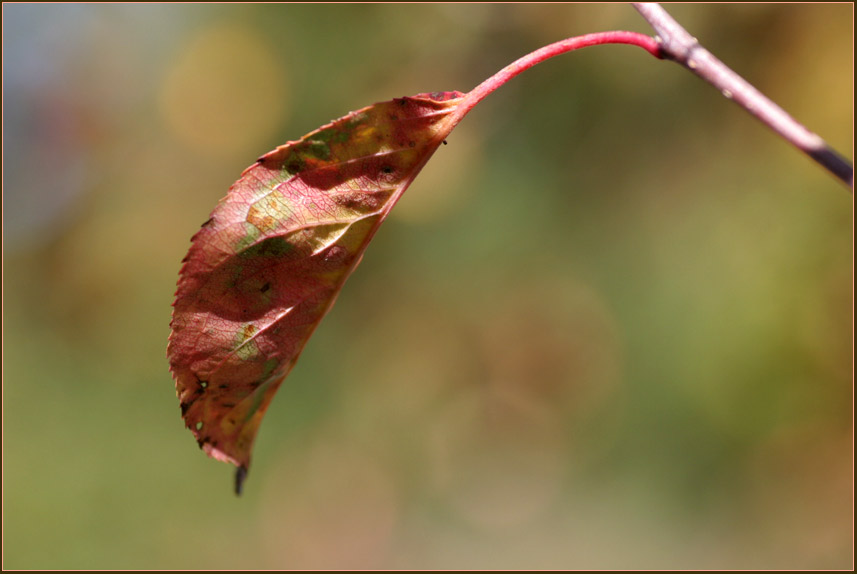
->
3;4;854;569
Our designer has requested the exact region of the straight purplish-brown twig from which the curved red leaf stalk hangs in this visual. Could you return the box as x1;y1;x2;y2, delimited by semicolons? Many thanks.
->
633;2;854;190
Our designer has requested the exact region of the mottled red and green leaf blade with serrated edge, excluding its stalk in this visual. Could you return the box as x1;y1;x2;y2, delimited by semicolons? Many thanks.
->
167;92;466;494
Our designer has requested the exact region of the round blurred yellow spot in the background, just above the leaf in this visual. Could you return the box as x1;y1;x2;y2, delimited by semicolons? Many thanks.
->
160;24;288;156
